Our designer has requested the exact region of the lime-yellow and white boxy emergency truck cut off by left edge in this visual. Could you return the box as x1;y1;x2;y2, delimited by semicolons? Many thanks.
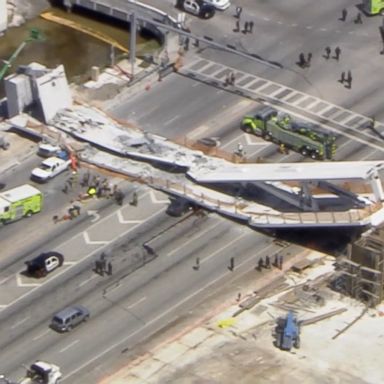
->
0;184;43;224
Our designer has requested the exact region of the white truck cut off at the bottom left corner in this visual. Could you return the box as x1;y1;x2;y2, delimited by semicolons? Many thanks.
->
0;360;62;384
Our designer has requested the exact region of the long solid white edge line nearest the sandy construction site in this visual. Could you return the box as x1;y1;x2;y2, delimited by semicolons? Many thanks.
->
63;244;274;380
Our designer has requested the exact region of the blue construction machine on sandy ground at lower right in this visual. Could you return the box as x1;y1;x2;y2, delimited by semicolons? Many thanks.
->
275;311;300;351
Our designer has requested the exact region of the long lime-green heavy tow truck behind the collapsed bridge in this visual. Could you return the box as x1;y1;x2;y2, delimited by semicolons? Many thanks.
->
241;106;336;160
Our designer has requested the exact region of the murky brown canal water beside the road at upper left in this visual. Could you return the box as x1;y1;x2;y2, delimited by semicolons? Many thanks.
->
0;8;159;96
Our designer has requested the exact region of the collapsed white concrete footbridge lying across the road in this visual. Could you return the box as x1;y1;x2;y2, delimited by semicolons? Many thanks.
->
41;106;384;228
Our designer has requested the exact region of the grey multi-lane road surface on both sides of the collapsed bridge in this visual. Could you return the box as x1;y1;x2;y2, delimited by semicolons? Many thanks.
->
0;0;384;384
